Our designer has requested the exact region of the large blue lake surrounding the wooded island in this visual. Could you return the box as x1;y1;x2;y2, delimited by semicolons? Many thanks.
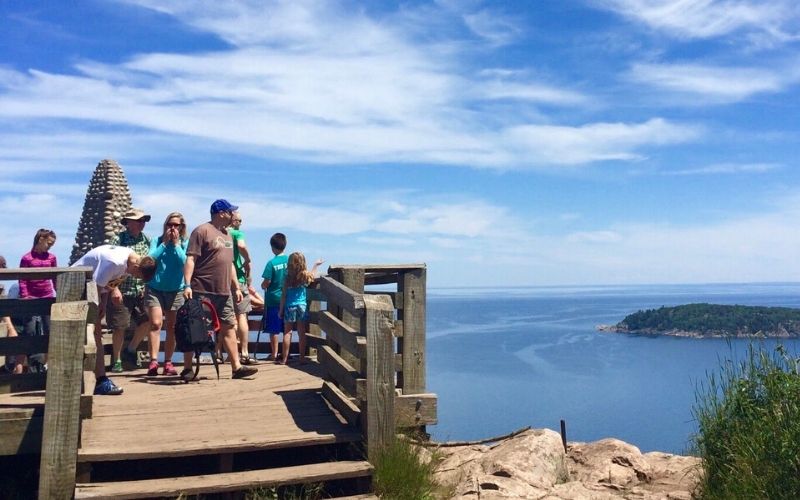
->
427;283;800;453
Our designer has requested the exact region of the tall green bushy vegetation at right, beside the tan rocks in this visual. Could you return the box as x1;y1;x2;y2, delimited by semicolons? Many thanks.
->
694;347;800;500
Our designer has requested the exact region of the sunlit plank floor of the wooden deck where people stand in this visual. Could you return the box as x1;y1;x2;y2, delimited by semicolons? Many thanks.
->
78;363;360;462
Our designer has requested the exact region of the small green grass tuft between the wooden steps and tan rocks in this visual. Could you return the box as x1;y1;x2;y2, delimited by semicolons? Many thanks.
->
372;439;448;500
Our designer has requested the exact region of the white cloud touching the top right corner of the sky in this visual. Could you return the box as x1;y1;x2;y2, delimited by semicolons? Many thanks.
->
590;0;800;42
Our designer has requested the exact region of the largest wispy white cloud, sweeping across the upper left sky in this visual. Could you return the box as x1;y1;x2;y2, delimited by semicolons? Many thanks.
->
0;0;697;169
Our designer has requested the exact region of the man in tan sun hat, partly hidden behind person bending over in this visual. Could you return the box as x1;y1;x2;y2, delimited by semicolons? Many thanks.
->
106;207;150;373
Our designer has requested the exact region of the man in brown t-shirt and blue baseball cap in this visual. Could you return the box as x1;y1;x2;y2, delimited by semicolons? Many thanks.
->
181;200;258;379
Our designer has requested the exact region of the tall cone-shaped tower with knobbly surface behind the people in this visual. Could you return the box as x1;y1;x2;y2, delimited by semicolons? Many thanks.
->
69;160;131;265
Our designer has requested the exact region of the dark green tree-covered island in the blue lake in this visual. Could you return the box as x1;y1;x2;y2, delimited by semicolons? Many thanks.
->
597;304;800;338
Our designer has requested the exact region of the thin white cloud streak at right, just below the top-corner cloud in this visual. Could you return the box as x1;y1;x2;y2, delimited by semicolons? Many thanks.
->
630;64;800;100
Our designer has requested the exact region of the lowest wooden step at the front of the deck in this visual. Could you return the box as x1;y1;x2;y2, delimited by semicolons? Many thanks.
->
75;461;372;500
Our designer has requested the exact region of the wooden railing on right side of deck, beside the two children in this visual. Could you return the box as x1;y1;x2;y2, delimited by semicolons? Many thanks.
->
308;264;437;457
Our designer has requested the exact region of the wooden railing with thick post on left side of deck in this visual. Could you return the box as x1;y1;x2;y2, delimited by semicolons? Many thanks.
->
0;267;98;499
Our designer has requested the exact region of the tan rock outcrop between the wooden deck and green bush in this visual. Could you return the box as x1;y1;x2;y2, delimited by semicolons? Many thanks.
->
436;429;700;500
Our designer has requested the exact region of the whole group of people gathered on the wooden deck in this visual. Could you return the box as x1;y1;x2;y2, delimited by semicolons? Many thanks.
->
3;199;323;395
